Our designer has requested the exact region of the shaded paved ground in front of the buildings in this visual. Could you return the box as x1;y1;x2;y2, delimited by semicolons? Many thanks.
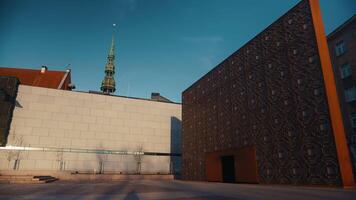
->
0;180;356;200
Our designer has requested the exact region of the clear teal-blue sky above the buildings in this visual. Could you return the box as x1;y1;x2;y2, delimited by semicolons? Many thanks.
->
0;0;356;102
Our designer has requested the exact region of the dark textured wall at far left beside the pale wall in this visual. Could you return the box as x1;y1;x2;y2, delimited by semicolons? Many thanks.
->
0;76;19;146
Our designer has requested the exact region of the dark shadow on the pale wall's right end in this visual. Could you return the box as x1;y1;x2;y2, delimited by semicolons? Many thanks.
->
170;117;182;179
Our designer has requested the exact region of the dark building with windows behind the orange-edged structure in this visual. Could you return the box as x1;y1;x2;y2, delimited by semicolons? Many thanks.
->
328;15;356;181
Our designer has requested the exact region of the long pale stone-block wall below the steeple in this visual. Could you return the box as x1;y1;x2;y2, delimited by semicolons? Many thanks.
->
0;85;181;173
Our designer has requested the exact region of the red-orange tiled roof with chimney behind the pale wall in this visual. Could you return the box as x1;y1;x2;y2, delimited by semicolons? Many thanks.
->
0;67;71;90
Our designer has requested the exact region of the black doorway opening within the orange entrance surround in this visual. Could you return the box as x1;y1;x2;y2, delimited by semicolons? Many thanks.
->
220;156;235;183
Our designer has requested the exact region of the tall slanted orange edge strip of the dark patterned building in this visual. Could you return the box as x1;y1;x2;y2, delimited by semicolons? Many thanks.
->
309;0;355;187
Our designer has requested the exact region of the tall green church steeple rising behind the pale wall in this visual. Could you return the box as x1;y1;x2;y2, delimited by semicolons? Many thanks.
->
100;24;115;94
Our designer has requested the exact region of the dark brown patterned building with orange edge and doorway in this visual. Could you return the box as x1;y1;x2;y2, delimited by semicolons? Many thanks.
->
182;0;355;187
